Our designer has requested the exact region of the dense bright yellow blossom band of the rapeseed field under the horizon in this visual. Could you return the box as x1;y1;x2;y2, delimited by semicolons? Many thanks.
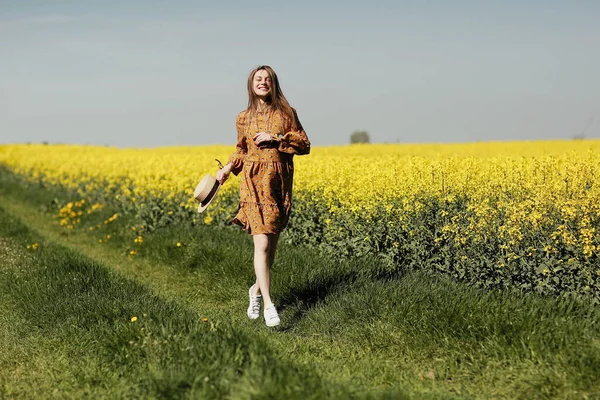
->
0;140;600;210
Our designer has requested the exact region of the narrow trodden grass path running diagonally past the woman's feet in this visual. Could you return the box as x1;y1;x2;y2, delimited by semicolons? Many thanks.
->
3;198;422;398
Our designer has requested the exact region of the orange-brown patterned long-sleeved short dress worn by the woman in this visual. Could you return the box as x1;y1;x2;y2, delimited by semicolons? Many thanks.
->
229;110;310;235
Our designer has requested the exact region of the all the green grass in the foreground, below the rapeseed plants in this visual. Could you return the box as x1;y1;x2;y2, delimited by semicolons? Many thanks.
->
0;183;600;398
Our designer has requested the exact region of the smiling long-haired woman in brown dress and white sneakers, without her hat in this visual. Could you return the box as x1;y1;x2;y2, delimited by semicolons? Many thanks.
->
217;65;310;326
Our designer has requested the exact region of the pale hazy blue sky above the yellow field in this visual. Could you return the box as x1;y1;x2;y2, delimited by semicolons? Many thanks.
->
0;0;600;147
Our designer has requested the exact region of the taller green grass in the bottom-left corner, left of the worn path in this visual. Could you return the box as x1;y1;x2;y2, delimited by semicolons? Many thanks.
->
0;206;348;398
